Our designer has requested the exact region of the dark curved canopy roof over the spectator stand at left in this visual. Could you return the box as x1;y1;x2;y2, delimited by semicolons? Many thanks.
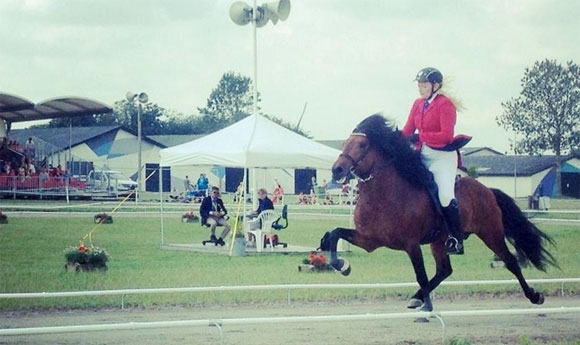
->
0;93;113;123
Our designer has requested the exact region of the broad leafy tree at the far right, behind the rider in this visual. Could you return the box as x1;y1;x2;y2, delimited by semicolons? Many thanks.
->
496;59;580;196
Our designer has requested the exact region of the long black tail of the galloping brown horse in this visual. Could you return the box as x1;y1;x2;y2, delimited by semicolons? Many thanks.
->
490;188;558;271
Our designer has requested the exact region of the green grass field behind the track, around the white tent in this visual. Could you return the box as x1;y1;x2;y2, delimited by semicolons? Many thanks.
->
0;196;580;310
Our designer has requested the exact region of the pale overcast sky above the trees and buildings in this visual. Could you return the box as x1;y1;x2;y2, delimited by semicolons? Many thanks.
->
0;0;580;153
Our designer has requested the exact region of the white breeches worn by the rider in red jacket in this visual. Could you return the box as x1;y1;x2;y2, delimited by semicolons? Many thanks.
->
421;145;457;207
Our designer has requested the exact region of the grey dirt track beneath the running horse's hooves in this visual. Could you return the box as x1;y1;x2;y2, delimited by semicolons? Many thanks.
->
0;296;580;345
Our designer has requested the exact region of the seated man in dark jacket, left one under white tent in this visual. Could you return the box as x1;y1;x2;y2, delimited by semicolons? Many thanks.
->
199;186;230;246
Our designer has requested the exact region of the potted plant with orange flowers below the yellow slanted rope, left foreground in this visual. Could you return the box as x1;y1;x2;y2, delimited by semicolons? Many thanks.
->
64;244;109;272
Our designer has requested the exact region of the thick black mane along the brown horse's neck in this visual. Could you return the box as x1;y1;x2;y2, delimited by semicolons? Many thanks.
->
353;114;432;188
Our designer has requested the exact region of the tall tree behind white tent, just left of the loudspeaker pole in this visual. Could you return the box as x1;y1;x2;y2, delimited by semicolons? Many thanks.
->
197;72;254;133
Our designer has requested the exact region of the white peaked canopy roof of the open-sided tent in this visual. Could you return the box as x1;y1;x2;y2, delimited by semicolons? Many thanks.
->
159;115;340;169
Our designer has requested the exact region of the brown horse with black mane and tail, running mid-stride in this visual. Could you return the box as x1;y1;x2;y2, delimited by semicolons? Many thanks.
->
320;114;557;311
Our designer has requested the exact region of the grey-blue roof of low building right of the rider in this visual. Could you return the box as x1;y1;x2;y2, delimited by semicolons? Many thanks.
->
462;155;573;176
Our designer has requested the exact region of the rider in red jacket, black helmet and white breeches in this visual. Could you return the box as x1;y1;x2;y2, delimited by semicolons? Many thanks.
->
402;67;463;255
